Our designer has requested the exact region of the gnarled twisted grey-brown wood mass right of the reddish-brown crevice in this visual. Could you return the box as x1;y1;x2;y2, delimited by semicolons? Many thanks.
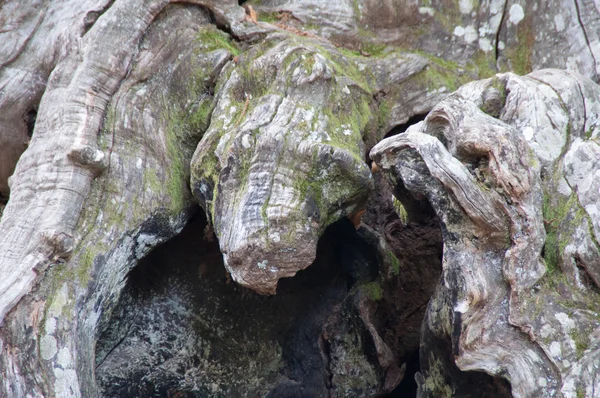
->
371;70;600;397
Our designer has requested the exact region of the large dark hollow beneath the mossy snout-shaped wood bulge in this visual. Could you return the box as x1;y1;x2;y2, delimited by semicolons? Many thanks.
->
96;211;378;397
